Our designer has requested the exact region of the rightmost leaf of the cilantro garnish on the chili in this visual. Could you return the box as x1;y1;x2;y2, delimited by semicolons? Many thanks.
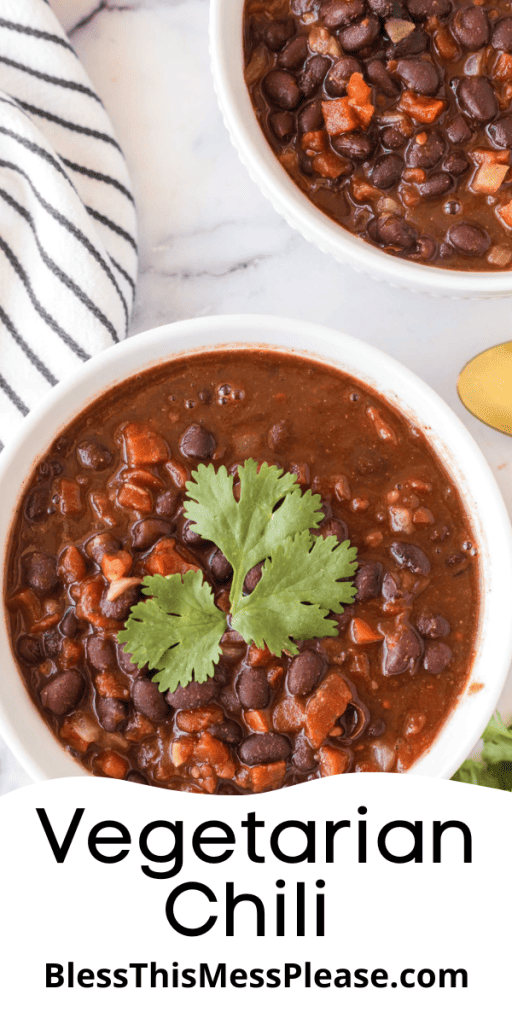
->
231;530;356;654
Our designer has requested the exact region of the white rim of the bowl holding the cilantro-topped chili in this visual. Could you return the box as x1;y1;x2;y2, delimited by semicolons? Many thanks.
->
0;315;512;779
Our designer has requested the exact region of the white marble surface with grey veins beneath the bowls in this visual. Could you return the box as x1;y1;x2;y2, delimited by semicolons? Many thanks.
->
0;0;512;794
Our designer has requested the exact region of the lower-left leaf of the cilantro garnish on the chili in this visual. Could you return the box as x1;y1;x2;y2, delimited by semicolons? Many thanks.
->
118;569;226;693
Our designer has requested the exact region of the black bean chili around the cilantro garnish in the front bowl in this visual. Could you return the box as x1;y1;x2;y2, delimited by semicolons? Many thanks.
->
6;349;479;794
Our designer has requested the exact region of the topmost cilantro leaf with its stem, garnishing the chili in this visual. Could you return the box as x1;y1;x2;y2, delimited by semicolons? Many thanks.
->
184;459;324;610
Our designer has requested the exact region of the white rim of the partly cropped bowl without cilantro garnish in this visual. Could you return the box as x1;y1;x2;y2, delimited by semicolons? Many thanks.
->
210;0;512;299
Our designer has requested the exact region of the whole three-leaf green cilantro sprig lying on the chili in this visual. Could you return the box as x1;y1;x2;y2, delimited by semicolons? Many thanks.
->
118;459;357;692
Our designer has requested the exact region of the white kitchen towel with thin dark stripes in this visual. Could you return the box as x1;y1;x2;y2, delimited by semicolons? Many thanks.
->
0;0;137;447
